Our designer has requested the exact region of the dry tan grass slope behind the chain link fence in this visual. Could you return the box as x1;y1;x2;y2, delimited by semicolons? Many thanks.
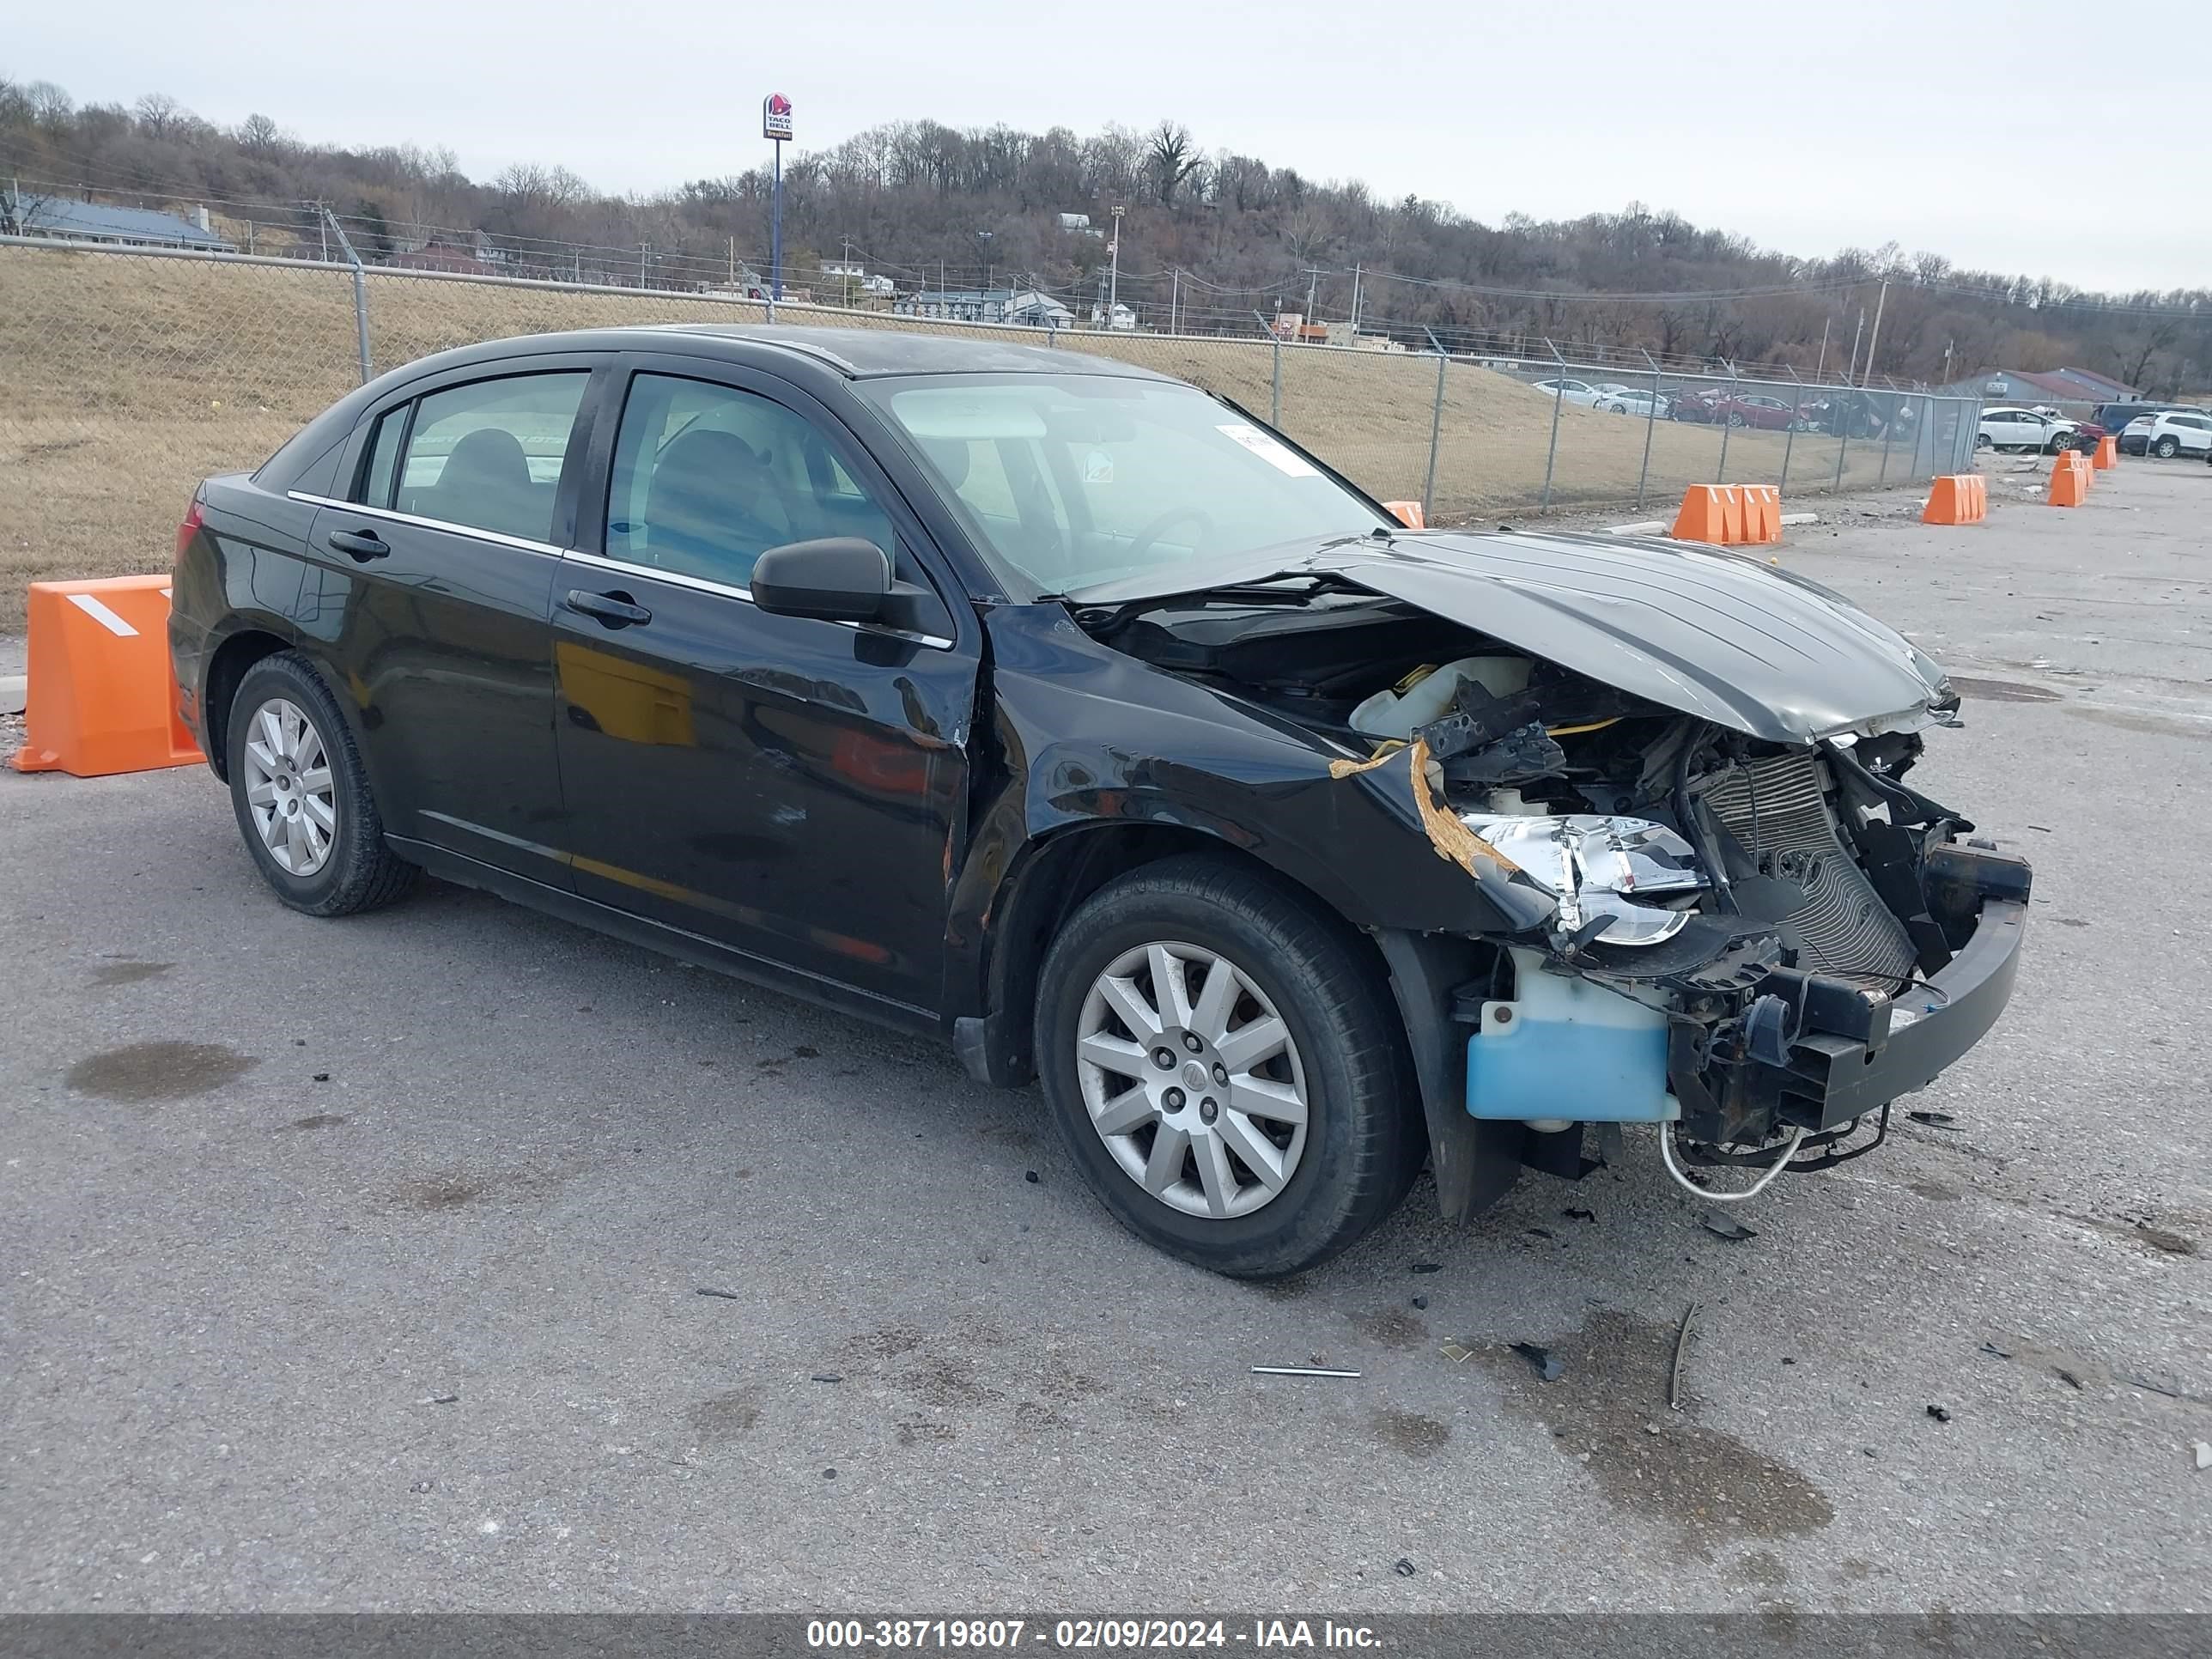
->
0;248;1905;630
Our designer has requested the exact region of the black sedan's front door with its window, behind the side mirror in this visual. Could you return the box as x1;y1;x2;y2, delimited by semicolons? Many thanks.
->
553;356;978;1011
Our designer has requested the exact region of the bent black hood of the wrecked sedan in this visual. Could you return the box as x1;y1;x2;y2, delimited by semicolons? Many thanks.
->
1291;533;1954;744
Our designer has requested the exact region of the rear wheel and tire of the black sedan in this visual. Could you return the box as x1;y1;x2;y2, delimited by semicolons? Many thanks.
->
226;650;418;915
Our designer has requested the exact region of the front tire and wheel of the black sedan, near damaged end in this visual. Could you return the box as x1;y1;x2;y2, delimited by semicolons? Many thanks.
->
1037;856;1427;1279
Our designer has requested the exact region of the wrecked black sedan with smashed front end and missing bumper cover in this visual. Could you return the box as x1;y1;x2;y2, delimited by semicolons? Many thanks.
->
168;325;2028;1276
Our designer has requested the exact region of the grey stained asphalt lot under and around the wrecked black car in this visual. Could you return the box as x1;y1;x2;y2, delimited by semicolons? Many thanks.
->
0;465;2212;1613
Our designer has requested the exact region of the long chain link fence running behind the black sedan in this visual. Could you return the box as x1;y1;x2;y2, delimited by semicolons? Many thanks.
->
0;237;1978;626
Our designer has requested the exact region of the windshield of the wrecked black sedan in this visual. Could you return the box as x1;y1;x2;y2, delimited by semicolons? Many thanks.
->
858;374;1395;598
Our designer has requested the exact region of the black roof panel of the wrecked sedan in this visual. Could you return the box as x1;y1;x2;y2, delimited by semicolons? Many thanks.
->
447;323;1172;380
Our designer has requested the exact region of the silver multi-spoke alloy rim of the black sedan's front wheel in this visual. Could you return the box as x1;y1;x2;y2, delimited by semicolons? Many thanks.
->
1075;942;1307;1218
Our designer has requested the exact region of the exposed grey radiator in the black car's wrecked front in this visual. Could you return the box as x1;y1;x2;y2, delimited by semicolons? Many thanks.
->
1697;754;1917;991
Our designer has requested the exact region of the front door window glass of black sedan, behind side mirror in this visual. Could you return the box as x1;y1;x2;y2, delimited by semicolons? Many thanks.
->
606;374;914;588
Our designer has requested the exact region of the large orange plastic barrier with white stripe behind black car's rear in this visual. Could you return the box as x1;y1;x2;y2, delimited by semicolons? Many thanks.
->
15;575;204;779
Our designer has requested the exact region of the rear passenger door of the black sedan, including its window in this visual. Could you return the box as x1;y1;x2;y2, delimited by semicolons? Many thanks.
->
299;352;613;887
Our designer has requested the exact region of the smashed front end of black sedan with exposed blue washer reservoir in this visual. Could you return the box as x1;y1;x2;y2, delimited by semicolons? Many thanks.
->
1091;553;2028;1214
